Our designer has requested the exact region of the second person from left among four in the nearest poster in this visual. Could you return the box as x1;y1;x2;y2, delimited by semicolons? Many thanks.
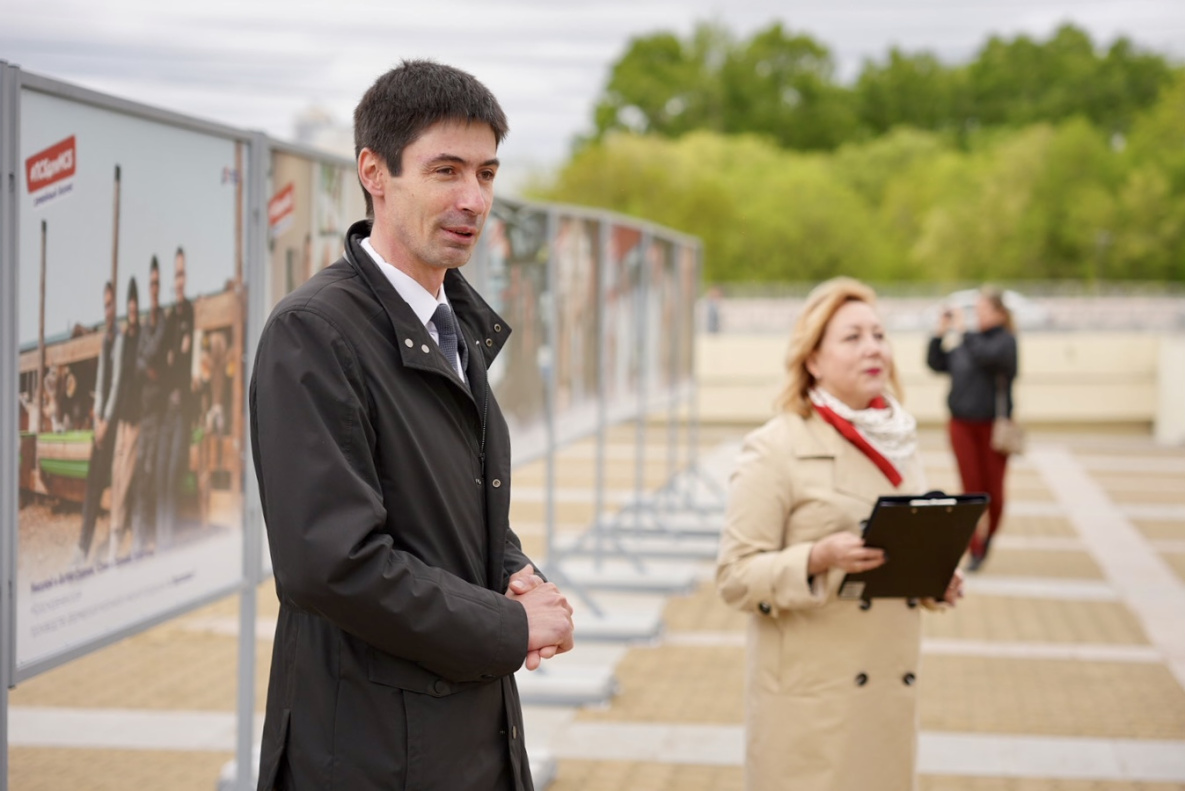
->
107;277;141;565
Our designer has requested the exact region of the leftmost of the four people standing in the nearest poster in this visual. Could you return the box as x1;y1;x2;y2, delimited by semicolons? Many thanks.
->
70;281;120;568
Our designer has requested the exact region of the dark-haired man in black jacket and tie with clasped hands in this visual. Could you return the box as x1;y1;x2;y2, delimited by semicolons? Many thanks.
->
250;62;572;791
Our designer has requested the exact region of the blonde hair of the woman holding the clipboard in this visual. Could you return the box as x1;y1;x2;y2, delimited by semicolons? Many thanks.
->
776;277;902;417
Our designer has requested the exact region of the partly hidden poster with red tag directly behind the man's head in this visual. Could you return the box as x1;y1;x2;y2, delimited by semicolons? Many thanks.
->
268;149;366;309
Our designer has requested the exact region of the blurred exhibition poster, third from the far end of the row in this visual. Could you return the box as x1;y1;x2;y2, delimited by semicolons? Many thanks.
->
601;224;642;423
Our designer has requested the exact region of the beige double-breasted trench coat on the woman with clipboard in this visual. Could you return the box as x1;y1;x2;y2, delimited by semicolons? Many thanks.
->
716;413;924;791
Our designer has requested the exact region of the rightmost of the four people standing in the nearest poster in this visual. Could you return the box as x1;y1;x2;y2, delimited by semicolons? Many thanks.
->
155;247;193;549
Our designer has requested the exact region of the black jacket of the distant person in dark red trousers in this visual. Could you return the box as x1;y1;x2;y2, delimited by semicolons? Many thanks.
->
925;327;1017;420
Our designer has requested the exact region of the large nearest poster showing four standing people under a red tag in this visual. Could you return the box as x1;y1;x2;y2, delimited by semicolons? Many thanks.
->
13;88;250;679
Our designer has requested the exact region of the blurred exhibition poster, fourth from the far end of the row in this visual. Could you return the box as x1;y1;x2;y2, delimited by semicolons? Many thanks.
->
553;214;601;443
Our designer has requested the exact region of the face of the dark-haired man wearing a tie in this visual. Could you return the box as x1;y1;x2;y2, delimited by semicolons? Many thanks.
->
374;121;498;278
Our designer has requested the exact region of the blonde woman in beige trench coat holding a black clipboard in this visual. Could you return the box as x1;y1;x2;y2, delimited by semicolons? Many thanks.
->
716;278;962;791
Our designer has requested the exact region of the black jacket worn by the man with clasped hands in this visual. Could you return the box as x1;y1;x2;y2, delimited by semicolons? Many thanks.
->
250;221;532;791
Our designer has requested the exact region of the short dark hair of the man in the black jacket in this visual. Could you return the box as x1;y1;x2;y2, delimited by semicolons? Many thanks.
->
354;60;508;217
